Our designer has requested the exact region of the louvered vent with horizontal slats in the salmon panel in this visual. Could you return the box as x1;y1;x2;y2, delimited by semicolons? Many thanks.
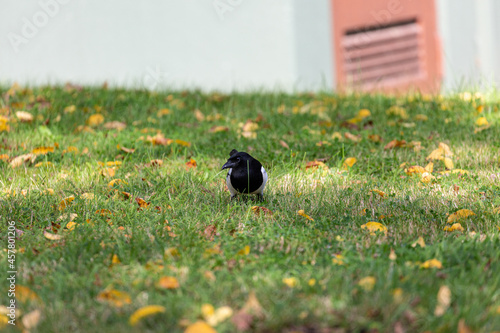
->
342;20;425;89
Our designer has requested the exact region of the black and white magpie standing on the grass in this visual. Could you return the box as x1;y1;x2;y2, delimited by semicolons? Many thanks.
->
222;149;267;200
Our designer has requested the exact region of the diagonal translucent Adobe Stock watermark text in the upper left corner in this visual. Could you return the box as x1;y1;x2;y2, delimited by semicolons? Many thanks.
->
7;0;71;53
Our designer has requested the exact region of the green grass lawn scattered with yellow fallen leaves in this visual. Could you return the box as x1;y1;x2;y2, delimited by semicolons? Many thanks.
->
0;85;500;333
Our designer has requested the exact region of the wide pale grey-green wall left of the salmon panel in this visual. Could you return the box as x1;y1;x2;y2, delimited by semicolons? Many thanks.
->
0;0;333;91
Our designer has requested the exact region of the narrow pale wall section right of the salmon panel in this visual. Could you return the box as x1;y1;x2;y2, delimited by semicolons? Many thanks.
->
437;0;500;90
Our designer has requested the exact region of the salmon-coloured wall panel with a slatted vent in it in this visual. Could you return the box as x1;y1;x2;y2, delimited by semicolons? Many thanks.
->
331;0;442;93
